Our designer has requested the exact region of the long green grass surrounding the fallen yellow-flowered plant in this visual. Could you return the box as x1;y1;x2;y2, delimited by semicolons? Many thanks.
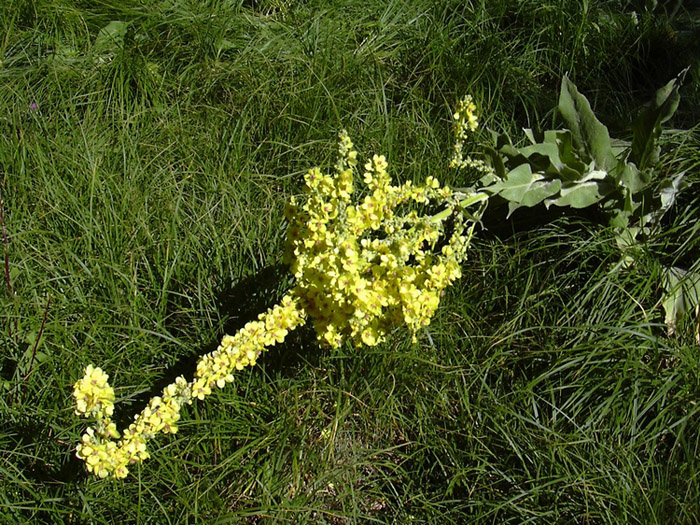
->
0;0;700;524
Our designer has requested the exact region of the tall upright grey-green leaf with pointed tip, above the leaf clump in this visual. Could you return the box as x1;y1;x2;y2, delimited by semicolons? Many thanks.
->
559;76;617;171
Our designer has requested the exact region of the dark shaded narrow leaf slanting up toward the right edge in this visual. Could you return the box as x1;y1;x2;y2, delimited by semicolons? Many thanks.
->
630;69;688;171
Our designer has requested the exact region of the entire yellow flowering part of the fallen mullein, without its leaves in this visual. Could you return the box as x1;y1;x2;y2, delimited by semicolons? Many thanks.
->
73;97;488;478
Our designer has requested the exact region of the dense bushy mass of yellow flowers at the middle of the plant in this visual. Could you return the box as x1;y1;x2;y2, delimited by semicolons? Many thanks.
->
287;132;471;347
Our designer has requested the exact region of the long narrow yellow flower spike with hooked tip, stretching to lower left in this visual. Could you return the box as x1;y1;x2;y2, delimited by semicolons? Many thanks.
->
73;291;305;478
